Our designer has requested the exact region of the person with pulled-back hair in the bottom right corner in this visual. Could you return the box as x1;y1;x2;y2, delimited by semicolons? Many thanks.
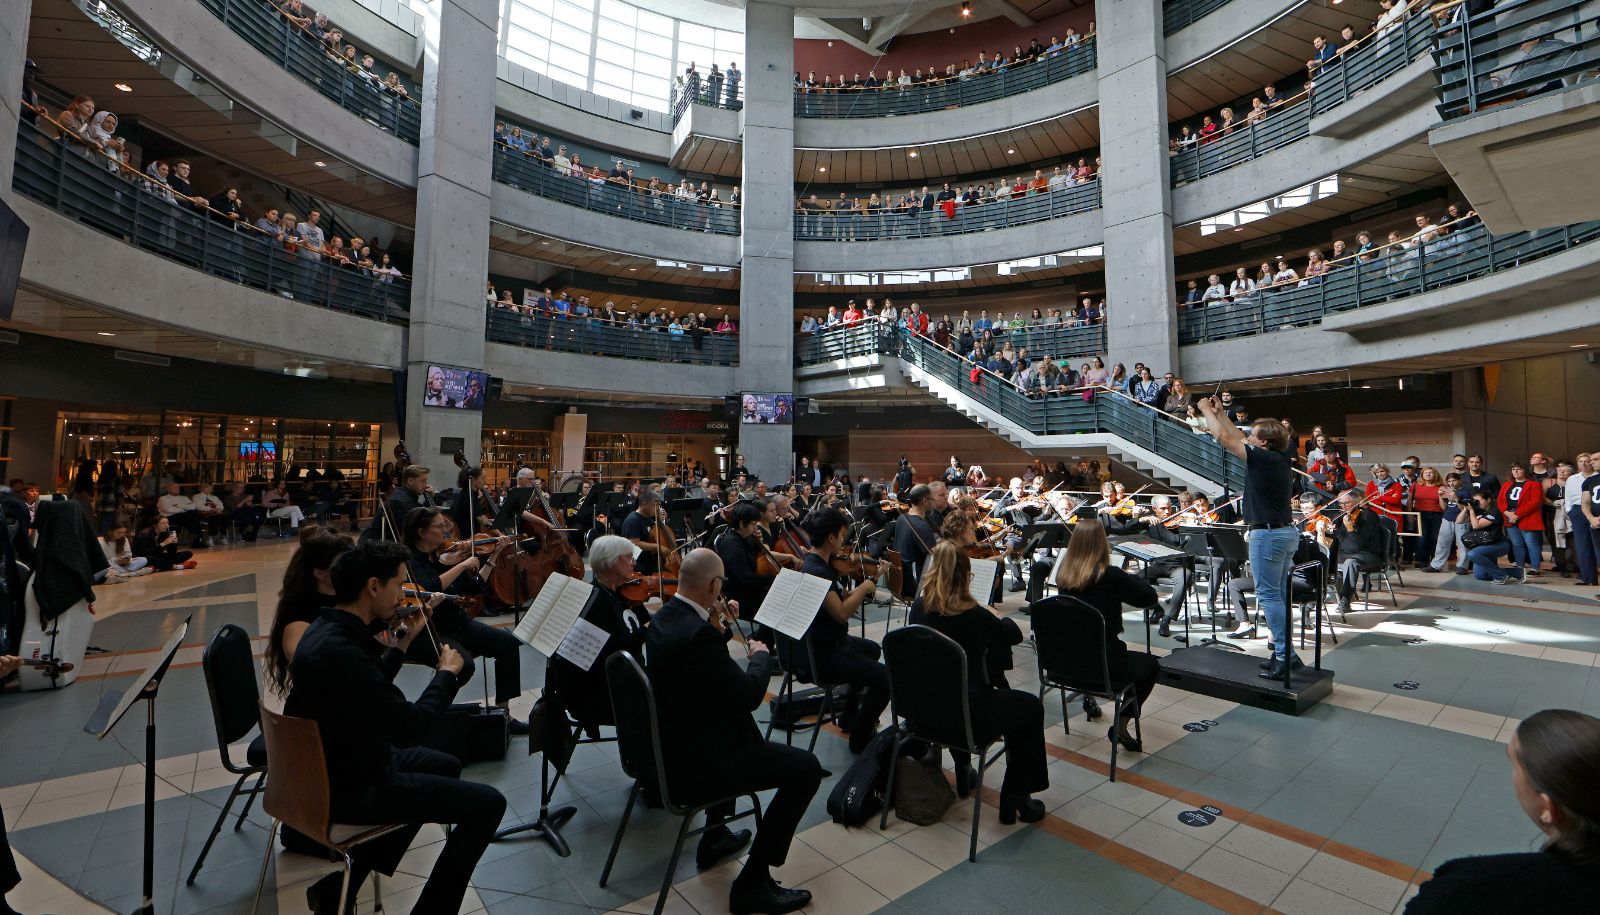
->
1405;709;1600;915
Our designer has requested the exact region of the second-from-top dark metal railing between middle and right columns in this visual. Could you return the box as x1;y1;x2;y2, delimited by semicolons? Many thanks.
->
795;179;1101;242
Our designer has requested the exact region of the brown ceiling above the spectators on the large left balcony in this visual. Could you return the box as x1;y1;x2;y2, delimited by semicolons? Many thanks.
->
27;0;416;226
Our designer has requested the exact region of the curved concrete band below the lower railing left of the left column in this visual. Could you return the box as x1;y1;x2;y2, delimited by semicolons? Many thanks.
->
12;198;402;367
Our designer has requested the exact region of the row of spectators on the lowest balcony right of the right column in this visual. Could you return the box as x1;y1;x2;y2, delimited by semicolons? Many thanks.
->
1178;203;1482;309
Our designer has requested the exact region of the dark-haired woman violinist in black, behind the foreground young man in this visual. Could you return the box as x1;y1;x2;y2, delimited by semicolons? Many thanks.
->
400;509;528;734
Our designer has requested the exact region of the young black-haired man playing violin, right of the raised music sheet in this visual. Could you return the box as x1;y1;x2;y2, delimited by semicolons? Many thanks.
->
794;511;889;753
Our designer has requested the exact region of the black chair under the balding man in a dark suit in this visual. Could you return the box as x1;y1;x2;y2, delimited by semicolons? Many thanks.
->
600;651;762;915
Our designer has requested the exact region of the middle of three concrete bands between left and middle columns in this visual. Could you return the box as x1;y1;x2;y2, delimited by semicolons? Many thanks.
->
490;184;739;267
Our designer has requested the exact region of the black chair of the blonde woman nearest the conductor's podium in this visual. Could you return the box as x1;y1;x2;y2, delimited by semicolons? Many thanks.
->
1030;593;1144;781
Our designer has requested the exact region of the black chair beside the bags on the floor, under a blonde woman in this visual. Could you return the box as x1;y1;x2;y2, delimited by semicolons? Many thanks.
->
878;624;1006;862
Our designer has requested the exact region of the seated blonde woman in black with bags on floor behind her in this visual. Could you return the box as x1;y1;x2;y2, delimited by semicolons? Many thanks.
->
910;542;1050;824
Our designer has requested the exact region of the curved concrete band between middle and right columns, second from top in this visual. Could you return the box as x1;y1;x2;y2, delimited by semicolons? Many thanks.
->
794;210;1102;273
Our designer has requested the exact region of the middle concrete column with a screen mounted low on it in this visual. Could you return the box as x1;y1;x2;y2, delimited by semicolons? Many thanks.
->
734;2;795;481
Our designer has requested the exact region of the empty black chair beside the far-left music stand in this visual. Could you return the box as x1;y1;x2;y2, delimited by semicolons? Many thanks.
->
184;624;267;886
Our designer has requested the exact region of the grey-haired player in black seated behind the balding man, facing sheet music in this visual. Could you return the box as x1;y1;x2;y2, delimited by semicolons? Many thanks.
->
546;534;650;726
